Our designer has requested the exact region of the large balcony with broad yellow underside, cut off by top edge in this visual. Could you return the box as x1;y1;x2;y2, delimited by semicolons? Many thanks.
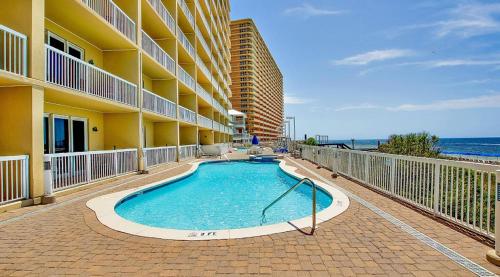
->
45;0;137;50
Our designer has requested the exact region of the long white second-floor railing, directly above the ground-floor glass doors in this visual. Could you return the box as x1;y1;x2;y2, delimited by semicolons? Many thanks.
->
45;45;137;107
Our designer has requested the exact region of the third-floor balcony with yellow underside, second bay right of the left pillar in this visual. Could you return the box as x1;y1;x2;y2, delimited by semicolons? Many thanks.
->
142;31;175;79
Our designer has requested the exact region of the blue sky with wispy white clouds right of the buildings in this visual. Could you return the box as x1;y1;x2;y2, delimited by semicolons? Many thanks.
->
231;0;500;139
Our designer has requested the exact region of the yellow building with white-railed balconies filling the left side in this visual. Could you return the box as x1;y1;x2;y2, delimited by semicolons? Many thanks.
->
0;0;232;205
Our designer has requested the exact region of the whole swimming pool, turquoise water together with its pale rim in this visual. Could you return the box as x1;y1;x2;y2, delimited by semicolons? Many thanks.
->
87;158;349;240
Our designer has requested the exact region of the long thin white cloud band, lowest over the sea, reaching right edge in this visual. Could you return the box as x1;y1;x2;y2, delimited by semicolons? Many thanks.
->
335;94;500;112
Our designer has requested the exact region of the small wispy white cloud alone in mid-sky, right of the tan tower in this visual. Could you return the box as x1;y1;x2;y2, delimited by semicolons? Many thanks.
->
332;49;415;65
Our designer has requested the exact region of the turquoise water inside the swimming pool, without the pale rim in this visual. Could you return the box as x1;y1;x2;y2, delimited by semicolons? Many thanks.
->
115;161;332;230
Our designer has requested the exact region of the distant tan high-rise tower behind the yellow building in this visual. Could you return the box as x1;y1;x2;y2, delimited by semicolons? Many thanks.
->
231;19;284;141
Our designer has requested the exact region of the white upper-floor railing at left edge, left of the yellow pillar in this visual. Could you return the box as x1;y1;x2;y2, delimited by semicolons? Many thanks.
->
0;25;28;76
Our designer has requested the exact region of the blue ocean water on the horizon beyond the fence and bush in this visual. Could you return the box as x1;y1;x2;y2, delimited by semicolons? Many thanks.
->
324;138;500;158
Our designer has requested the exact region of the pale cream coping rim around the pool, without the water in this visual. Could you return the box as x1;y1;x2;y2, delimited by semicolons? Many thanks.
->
86;160;350;240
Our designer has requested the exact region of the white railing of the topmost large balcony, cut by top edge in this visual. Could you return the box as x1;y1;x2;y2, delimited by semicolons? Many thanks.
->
82;0;136;42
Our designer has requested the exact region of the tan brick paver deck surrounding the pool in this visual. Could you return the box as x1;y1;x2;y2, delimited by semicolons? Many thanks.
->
0;154;500;276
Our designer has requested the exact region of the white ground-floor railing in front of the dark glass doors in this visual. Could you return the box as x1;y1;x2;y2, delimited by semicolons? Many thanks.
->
45;149;137;195
